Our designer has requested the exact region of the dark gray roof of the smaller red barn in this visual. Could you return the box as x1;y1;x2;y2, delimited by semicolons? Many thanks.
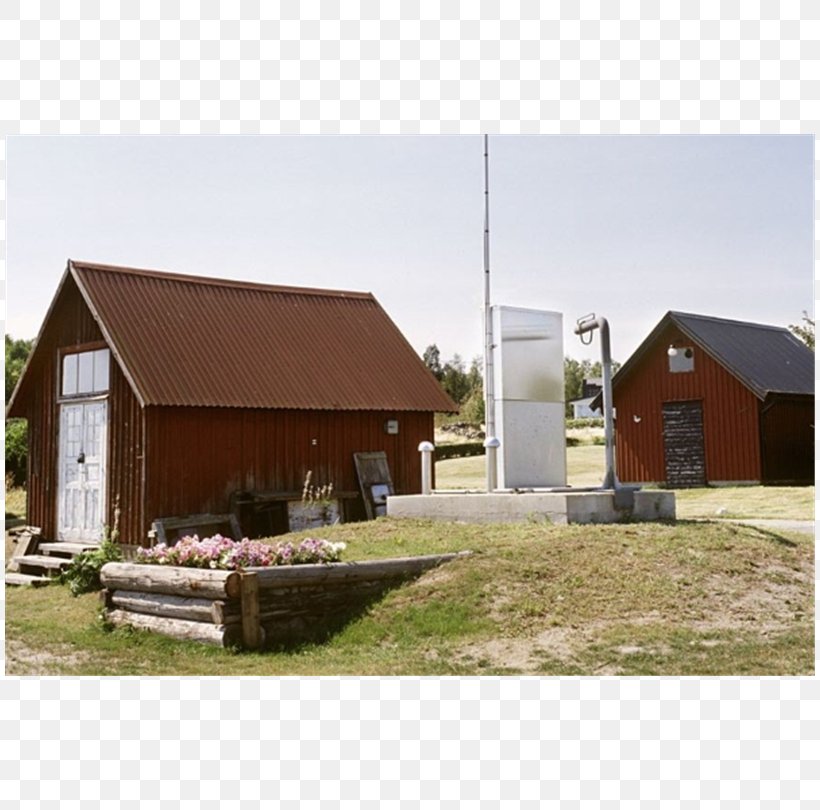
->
596;311;814;408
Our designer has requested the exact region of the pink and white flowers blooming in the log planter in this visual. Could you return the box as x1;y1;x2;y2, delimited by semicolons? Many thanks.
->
137;534;345;570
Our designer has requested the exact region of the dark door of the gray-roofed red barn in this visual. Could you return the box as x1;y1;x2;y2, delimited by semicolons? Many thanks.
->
663;401;706;488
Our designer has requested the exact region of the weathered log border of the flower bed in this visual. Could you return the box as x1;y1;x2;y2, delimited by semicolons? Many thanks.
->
100;551;471;650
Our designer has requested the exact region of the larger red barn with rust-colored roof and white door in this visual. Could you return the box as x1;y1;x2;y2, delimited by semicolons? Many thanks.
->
7;261;455;544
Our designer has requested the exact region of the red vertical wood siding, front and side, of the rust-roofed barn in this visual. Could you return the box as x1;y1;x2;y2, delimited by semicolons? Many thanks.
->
18;276;446;544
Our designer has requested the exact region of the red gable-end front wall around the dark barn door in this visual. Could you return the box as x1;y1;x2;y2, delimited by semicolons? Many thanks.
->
613;326;761;482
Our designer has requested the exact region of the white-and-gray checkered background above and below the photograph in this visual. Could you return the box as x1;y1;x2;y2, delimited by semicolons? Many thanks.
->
0;0;820;810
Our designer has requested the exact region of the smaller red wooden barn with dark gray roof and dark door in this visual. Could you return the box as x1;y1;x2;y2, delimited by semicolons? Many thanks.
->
599;312;814;487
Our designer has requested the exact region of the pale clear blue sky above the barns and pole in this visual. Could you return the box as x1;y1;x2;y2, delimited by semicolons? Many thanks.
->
6;136;814;361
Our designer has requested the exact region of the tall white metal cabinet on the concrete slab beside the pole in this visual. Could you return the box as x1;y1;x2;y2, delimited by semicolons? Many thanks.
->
491;306;567;489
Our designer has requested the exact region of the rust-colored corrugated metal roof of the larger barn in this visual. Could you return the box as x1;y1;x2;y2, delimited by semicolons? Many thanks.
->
70;262;455;411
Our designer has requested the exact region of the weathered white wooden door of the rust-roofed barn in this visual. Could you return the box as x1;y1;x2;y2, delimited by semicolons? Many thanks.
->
57;400;108;543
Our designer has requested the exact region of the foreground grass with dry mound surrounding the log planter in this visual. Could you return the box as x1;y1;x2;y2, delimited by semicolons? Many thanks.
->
6;518;814;676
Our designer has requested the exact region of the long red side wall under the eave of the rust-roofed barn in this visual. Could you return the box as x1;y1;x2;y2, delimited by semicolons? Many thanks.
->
143;407;433;536
